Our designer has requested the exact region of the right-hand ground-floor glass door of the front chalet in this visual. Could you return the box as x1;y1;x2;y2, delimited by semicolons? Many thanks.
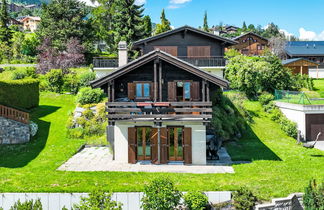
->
168;127;183;161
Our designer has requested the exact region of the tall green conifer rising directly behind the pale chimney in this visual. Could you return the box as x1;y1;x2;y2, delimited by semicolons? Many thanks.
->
113;0;145;46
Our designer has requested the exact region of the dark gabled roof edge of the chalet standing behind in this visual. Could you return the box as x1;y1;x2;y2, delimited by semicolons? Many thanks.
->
133;25;237;46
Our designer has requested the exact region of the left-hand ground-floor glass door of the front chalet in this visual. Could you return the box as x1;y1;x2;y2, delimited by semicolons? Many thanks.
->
136;127;152;160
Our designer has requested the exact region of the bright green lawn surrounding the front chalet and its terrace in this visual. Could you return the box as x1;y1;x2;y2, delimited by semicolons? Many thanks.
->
0;93;324;199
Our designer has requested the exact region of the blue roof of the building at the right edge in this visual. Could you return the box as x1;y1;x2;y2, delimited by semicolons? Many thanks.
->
285;41;324;56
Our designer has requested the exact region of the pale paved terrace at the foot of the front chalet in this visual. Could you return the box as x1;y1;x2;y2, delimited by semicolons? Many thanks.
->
58;147;234;174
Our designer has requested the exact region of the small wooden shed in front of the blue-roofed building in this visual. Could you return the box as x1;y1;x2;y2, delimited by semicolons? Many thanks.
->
282;58;319;77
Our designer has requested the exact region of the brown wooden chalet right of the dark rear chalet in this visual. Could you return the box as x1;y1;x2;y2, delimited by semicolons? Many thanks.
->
231;32;269;56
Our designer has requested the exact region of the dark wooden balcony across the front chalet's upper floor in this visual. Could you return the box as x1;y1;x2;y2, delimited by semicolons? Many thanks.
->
106;102;212;122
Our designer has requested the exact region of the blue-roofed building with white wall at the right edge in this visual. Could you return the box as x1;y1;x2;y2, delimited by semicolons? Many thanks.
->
285;41;324;78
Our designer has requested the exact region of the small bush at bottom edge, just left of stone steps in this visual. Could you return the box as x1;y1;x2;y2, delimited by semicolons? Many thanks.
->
233;188;258;210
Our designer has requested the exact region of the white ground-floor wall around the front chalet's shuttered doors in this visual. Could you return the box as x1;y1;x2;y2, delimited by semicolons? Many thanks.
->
114;122;206;165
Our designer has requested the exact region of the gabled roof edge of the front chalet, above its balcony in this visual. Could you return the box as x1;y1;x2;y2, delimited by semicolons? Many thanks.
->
91;50;229;88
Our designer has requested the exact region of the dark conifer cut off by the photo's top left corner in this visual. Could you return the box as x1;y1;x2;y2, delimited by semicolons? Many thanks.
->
0;0;12;43
